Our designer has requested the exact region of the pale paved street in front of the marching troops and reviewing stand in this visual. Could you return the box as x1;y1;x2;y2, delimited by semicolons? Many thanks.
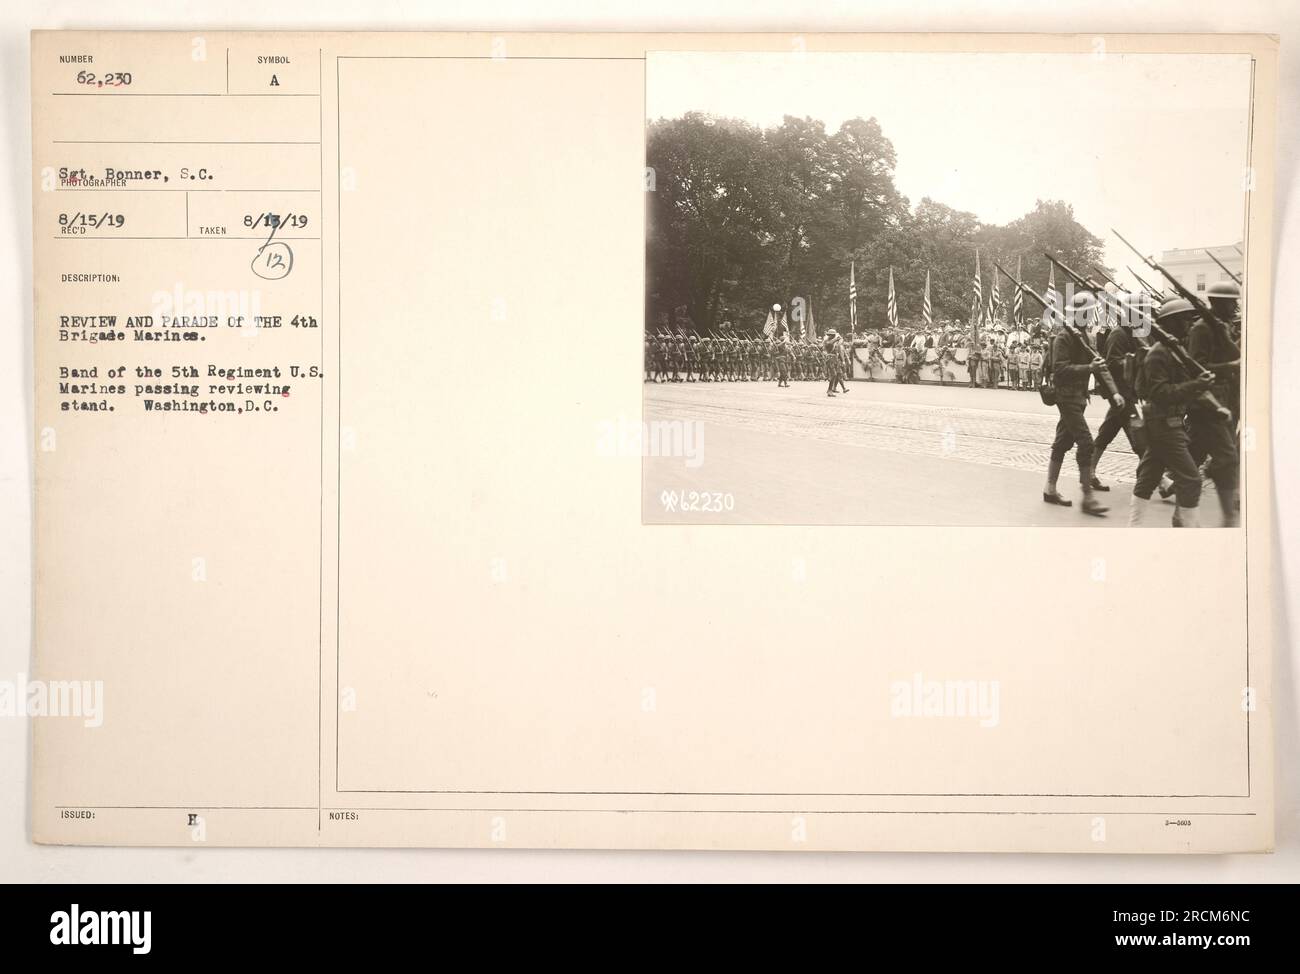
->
642;381;1201;528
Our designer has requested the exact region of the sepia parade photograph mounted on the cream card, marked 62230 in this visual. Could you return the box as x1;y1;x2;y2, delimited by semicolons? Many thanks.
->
644;48;1253;528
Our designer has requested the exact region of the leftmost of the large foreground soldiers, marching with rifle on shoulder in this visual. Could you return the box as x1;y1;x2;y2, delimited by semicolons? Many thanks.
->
1043;291;1123;518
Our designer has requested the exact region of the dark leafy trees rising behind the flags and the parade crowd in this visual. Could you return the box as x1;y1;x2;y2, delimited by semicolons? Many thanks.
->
646;112;1102;332
